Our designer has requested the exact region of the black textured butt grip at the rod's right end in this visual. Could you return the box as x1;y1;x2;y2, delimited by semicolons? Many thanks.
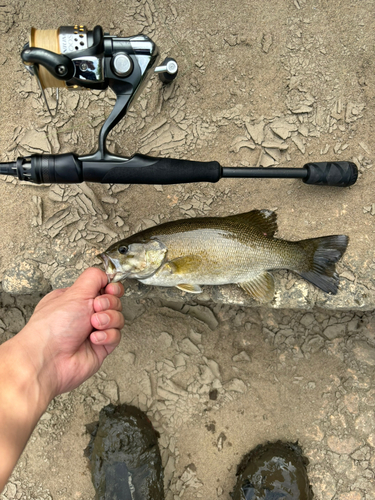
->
303;161;358;187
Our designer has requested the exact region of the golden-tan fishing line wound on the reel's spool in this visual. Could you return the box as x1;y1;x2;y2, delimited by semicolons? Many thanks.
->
29;28;67;89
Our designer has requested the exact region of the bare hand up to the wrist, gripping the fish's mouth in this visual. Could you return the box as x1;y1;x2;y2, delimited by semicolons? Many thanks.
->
14;268;124;404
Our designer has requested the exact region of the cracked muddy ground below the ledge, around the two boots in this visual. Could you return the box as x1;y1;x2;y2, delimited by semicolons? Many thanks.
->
0;293;375;500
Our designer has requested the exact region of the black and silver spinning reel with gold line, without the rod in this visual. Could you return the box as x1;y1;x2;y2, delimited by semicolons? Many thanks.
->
21;25;178;160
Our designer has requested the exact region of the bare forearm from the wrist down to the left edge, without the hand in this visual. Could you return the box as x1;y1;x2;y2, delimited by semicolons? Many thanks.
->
0;336;49;492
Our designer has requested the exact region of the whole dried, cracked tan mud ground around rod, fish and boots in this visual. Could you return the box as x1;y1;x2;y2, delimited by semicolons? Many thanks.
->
0;0;375;500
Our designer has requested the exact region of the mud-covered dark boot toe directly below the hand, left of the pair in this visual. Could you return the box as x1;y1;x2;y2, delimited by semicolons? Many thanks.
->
85;404;164;500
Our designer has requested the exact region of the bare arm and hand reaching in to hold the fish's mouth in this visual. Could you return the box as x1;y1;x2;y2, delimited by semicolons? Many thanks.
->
0;268;124;493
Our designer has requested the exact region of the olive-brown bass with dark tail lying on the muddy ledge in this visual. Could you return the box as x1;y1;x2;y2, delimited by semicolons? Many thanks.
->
98;210;349;302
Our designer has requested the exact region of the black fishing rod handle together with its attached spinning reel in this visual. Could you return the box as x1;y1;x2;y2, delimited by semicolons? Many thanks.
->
0;25;358;187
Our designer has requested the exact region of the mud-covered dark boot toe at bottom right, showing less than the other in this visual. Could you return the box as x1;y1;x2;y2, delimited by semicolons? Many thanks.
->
232;441;314;500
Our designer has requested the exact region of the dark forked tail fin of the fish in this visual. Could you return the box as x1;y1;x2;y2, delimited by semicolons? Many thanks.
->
296;234;349;295
